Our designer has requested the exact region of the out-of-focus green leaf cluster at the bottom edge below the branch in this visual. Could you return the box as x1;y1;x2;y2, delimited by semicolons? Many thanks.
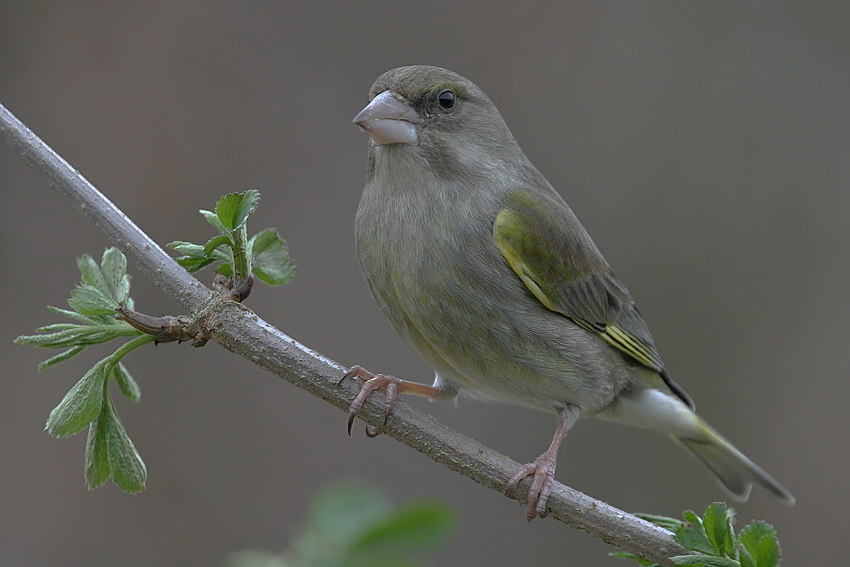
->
224;483;454;567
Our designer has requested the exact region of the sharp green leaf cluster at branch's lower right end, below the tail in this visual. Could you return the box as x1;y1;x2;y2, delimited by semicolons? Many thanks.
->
612;502;781;567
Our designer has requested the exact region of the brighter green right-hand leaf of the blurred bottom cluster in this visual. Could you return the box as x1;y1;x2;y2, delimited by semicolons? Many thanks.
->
352;502;454;552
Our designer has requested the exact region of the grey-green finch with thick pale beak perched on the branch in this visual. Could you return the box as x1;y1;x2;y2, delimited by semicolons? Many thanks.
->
343;65;794;520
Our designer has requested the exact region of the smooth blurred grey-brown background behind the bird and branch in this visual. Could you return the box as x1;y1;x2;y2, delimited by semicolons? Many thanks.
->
0;0;850;567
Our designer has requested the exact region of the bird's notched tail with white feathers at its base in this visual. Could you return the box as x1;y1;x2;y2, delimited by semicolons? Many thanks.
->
598;389;794;505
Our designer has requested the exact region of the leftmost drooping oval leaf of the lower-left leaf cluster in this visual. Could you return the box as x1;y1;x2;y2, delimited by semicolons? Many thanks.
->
45;358;110;437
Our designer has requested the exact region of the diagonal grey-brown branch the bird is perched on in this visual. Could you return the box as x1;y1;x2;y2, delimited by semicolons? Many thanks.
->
0;104;689;565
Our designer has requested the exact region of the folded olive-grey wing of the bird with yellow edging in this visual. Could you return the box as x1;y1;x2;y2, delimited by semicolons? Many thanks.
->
493;191;693;406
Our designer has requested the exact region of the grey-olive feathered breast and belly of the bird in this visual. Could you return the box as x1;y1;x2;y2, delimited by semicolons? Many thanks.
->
356;160;628;410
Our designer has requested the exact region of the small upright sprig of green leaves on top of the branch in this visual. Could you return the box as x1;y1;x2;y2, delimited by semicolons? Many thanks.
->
168;189;295;286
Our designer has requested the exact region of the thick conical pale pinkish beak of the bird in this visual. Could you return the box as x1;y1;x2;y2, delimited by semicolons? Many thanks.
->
354;91;422;145
